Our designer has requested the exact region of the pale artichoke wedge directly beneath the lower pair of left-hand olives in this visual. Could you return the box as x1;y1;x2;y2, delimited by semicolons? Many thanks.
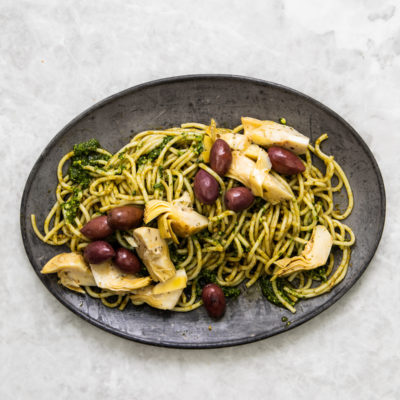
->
90;260;151;292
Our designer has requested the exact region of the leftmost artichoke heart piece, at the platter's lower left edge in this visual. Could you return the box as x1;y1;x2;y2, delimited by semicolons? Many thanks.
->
40;252;96;293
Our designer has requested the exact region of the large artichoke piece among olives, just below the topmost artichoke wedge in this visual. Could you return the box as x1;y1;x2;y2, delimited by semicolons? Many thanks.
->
227;148;293;204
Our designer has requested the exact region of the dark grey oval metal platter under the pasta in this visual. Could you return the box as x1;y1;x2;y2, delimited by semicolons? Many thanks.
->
21;75;386;348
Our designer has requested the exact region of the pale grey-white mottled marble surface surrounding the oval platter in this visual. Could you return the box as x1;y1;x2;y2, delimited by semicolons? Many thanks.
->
0;0;400;400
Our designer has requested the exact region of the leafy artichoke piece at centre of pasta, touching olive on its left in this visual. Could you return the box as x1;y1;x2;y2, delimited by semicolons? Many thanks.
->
144;192;208;243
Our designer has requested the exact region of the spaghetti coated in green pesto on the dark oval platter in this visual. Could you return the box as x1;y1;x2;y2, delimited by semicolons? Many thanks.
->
31;123;355;312
